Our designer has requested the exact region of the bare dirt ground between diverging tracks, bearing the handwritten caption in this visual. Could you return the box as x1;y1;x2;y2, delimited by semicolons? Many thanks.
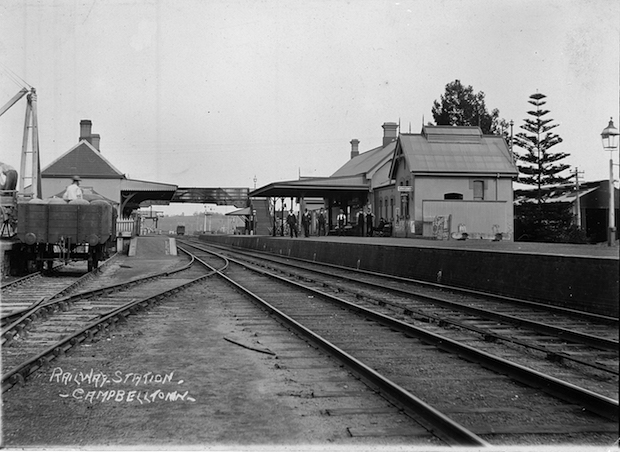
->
2;266;432;450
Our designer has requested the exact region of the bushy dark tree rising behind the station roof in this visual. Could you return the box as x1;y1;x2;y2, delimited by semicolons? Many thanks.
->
431;80;501;134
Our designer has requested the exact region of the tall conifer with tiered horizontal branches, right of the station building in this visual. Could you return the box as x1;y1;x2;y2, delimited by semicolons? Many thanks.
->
514;93;572;204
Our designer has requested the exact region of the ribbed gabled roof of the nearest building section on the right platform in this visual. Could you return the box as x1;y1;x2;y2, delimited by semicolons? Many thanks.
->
390;125;518;178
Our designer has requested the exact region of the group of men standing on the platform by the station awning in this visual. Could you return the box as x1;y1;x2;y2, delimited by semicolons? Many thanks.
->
286;207;387;238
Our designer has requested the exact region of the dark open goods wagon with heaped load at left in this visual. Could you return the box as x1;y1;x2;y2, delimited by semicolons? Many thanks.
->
16;198;117;271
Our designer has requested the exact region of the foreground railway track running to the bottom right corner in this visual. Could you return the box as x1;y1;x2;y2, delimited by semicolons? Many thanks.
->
182;242;618;445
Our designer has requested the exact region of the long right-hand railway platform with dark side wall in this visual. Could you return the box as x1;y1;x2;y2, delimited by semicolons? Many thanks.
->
200;235;619;316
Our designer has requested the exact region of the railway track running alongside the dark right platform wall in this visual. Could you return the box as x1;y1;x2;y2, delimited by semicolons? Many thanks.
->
186;240;619;399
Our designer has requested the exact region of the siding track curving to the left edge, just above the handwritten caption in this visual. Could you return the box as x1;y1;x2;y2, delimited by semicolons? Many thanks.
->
2;249;213;392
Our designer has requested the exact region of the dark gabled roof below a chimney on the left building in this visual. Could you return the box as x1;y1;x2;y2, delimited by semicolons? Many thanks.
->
41;140;125;179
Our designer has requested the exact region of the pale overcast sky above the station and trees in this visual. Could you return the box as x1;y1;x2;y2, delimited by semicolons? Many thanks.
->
0;0;620;215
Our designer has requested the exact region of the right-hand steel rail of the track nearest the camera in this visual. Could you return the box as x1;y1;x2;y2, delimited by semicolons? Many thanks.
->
196;245;619;421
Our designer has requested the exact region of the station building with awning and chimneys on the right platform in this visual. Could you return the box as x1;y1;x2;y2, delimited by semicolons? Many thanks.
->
250;122;518;240
